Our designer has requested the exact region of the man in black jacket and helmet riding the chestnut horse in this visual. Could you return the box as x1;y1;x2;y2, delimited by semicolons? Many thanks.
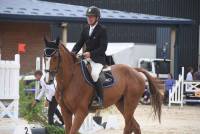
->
72;6;108;107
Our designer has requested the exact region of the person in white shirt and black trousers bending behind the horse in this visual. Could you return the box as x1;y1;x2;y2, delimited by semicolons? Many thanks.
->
32;70;64;125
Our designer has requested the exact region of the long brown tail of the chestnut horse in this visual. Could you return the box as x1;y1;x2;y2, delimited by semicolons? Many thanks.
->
134;68;163;122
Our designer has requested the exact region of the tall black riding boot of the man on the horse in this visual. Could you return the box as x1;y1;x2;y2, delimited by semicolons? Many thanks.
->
95;79;103;107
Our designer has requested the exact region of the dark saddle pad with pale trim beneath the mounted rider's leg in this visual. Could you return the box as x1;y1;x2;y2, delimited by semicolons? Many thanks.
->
80;60;115;88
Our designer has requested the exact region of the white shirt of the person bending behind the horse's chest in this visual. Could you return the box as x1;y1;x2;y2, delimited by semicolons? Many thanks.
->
35;77;55;101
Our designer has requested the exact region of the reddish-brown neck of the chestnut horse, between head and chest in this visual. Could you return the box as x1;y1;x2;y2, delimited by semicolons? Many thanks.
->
56;45;75;86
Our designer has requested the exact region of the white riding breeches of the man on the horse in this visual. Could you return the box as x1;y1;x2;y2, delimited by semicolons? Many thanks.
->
85;58;103;82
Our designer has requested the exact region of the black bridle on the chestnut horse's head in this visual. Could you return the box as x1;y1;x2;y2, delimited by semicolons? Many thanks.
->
44;47;61;78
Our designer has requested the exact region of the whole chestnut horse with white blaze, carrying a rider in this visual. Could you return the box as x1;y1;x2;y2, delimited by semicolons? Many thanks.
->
44;39;162;134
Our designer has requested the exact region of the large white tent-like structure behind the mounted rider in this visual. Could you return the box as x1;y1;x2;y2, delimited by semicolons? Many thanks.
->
66;42;156;67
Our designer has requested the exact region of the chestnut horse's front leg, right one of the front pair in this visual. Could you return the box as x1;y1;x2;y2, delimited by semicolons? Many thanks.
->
69;109;88;134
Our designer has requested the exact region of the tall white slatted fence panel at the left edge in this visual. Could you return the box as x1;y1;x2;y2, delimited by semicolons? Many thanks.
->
0;54;20;118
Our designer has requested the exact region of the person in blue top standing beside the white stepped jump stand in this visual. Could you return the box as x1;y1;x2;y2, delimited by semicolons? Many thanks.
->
164;73;175;103
